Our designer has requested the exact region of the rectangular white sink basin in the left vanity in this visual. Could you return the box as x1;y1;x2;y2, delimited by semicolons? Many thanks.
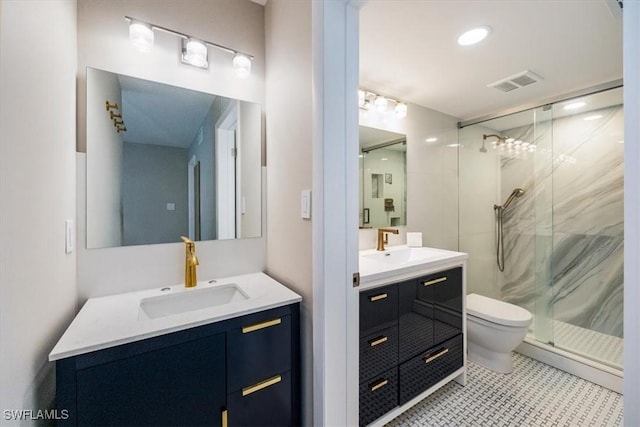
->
139;283;249;319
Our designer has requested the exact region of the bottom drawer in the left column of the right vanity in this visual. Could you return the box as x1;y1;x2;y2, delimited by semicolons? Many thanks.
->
360;368;398;426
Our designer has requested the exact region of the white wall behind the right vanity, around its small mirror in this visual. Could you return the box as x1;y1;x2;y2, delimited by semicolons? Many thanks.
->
360;101;458;250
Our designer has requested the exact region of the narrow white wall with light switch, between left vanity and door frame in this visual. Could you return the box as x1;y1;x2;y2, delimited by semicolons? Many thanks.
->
265;0;313;425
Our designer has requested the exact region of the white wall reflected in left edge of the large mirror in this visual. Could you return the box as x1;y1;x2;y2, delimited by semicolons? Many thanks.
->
87;70;123;248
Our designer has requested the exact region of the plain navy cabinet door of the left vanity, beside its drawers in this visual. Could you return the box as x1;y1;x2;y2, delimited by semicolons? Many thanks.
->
76;334;226;426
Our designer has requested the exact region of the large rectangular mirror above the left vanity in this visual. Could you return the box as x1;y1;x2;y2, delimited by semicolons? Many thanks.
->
87;68;262;248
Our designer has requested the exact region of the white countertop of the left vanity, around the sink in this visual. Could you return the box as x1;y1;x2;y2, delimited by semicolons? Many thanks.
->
49;273;302;361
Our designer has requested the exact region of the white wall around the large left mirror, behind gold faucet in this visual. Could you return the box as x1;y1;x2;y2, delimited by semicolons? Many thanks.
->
77;0;266;302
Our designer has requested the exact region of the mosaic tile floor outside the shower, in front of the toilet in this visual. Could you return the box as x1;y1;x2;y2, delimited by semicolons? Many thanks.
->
387;353;622;427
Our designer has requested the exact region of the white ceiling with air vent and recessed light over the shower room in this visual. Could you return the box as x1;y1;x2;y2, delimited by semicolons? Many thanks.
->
360;0;622;120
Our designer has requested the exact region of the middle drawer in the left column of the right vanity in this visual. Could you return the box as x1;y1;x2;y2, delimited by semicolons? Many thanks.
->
360;325;398;382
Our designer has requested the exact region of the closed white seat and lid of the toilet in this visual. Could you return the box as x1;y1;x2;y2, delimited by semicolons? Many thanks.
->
466;294;532;327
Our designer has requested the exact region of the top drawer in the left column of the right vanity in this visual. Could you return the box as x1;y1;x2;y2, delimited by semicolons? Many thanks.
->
360;284;398;336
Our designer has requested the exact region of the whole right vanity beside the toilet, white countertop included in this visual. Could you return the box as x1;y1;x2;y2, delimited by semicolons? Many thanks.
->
359;246;467;426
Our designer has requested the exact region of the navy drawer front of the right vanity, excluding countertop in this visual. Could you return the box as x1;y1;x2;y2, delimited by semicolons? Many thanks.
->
359;267;464;426
